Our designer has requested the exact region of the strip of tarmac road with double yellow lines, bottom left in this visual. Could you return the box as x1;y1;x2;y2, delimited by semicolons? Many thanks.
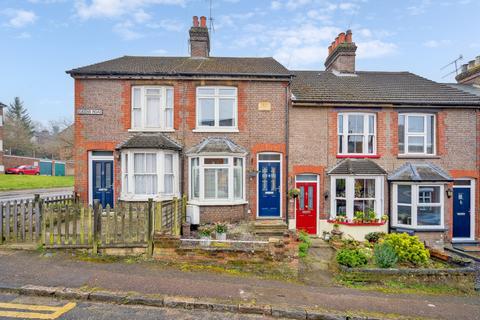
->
0;294;269;320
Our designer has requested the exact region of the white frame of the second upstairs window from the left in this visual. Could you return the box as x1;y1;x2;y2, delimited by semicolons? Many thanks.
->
193;86;238;132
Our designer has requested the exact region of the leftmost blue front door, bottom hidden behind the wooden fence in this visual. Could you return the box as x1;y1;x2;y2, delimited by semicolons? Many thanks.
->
92;160;113;208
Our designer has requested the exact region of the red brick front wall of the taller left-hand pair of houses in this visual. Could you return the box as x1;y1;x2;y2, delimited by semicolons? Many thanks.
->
75;79;287;221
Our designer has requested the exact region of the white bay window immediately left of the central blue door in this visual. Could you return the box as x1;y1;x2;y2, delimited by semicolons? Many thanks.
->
189;156;245;205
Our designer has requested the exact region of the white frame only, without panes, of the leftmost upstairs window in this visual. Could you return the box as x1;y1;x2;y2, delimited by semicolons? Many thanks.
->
129;85;175;132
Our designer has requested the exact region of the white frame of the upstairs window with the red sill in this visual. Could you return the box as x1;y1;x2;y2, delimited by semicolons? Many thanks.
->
337;112;377;156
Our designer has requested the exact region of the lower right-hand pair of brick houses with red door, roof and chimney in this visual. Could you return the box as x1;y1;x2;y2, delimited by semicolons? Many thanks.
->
288;31;480;243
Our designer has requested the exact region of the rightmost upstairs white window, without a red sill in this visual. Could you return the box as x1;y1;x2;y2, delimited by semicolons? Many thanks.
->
398;113;436;155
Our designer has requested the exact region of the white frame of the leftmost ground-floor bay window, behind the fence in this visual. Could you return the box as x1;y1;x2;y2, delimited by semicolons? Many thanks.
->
120;149;180;201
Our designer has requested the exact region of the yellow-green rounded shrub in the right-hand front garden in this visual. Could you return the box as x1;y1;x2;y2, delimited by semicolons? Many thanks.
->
384;233;430;266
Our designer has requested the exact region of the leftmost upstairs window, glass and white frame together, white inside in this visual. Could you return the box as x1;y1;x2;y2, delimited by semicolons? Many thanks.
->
132;86;173;131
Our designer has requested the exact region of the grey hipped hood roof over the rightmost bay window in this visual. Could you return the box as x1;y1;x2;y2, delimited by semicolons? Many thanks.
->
388;162;453;181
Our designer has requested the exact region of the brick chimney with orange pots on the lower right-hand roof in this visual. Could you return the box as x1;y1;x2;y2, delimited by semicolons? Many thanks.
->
325;30;357;73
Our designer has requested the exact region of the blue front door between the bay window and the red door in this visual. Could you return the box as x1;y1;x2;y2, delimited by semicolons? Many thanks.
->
258;162;281;218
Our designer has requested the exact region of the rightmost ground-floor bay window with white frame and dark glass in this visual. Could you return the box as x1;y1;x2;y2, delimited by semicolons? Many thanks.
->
392;183;444;229
